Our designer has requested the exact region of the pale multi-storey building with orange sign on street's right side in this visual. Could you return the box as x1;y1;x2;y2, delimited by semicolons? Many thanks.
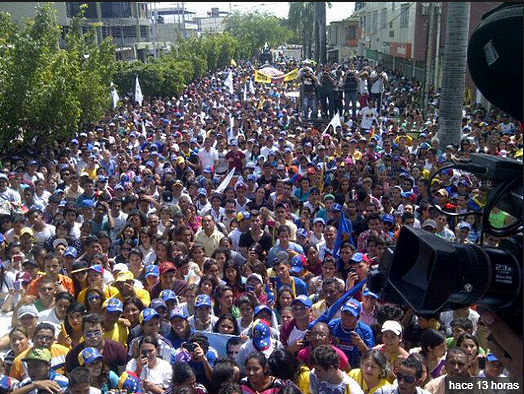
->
353;2;500;97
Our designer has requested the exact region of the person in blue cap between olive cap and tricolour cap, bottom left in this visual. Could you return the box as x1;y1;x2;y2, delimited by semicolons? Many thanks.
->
78;347;118;394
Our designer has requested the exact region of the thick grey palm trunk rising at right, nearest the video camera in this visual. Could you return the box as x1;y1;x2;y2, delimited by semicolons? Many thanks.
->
437;1;470;147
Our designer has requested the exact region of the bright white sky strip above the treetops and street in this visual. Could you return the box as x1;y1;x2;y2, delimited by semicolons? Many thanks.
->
157;2;355;24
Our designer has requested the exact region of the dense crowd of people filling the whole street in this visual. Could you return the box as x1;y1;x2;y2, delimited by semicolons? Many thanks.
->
0;54;522;394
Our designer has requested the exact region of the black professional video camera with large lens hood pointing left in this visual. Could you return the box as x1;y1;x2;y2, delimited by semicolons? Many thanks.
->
368;154;523;334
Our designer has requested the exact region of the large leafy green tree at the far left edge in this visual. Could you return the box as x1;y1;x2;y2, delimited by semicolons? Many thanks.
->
0;3;114;152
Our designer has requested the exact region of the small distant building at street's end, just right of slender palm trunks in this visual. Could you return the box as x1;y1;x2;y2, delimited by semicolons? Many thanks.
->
327;17;360;62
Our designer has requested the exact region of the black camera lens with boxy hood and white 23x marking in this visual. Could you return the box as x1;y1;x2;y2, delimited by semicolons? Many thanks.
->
381;227;522;313
